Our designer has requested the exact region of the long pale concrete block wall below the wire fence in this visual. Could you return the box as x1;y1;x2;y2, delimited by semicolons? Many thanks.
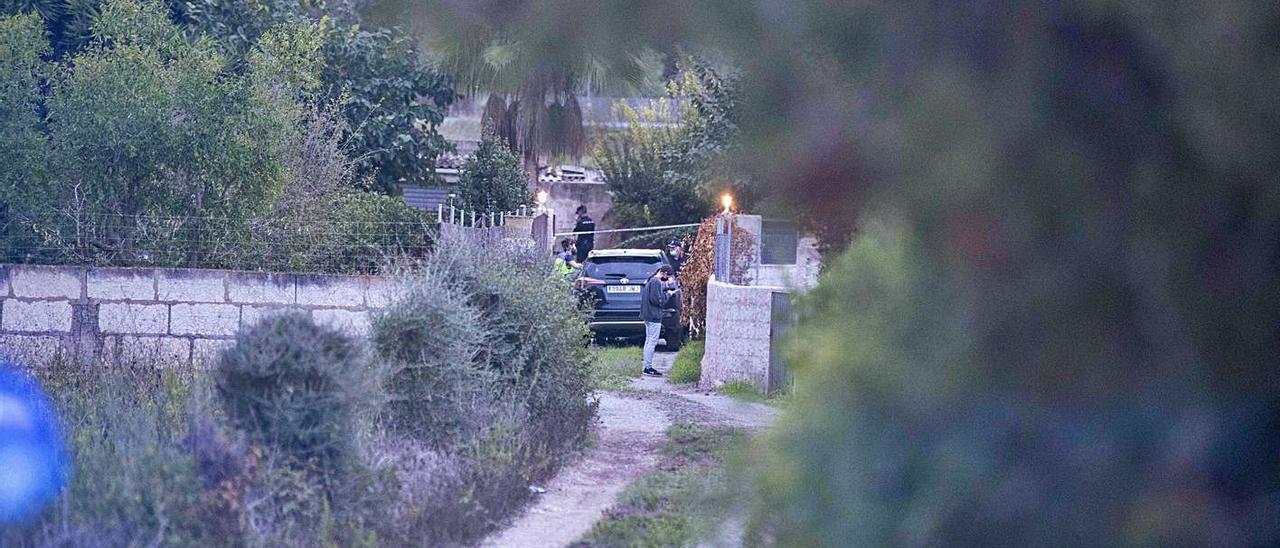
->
0;265;398;367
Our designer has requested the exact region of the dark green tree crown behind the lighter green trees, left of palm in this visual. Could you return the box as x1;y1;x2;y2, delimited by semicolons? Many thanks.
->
166;0;456;193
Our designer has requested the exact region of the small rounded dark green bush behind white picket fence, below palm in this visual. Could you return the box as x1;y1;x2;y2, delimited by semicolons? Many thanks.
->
458;137;532;211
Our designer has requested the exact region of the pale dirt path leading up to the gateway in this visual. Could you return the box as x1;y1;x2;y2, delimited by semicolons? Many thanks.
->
481;353;777;547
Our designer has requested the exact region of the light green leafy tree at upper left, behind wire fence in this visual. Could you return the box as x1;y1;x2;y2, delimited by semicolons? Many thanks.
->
0;0;308;265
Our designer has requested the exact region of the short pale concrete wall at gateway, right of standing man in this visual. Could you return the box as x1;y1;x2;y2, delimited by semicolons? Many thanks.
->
699;278;786;391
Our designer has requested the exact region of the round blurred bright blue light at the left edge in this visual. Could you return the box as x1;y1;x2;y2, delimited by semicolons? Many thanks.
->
0;357;68;525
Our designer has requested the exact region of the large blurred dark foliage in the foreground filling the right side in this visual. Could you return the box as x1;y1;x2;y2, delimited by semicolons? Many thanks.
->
414;0;1280;545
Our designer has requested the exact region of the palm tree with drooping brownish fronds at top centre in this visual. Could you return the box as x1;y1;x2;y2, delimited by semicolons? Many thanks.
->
367;0;664;172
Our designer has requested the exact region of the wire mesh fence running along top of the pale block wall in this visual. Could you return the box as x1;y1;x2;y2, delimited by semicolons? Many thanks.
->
0;211;436;273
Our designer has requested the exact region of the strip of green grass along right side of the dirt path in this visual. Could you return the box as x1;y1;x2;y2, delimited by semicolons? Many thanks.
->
573;424;746;547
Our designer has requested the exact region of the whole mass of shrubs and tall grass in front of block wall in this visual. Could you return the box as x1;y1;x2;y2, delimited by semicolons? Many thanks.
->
0;242;595;547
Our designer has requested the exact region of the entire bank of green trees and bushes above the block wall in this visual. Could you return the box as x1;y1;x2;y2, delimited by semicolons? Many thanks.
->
0;0;428;271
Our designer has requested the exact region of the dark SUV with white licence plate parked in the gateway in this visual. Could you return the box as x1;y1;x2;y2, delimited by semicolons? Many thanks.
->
577;250;685;351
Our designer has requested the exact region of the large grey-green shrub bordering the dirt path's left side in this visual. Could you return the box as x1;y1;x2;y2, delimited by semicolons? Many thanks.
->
370;234;595;544
